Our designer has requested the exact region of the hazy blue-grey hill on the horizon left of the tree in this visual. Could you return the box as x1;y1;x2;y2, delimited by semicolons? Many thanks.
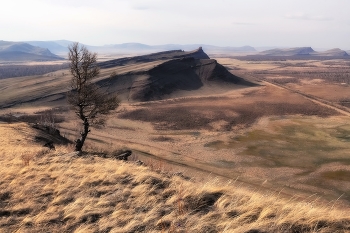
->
0;41;63;61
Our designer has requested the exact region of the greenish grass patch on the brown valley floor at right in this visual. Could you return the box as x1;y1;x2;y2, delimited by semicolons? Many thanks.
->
204;119;350;171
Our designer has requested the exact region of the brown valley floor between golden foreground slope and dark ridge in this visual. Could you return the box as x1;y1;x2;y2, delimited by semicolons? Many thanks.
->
53;82;350;205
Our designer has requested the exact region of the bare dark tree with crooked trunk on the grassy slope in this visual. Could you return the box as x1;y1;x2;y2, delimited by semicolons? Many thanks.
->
68;42;119;151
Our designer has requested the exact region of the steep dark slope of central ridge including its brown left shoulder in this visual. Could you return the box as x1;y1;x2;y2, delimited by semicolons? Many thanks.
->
102;57;254;101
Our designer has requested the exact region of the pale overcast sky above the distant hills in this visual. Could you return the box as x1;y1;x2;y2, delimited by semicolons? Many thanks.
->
0;0;350;49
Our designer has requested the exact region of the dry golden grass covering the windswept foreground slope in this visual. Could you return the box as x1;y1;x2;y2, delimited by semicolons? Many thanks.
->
0;124;350;232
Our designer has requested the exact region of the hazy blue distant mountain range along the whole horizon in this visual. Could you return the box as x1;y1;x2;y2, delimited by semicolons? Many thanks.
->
0;40;350;61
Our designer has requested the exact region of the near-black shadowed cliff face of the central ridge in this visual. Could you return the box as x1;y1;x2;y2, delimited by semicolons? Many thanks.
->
130;57;250;101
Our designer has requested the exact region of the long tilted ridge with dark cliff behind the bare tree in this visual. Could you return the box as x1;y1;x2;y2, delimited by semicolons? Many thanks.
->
0;48;254;107
